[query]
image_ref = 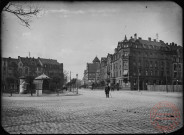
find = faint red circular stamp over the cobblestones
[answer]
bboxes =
[150,101,181,133]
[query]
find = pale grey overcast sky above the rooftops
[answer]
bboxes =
[1,2,182,79]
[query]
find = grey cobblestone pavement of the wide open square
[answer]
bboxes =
[1,89,183,134]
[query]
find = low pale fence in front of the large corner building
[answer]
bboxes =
[147,85,183,92]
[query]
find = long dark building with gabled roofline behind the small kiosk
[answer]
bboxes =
[2,56,64,92]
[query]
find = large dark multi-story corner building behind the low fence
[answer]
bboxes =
[112,34,183,90]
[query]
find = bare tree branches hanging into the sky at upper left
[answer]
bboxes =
[2,2,40,28]
